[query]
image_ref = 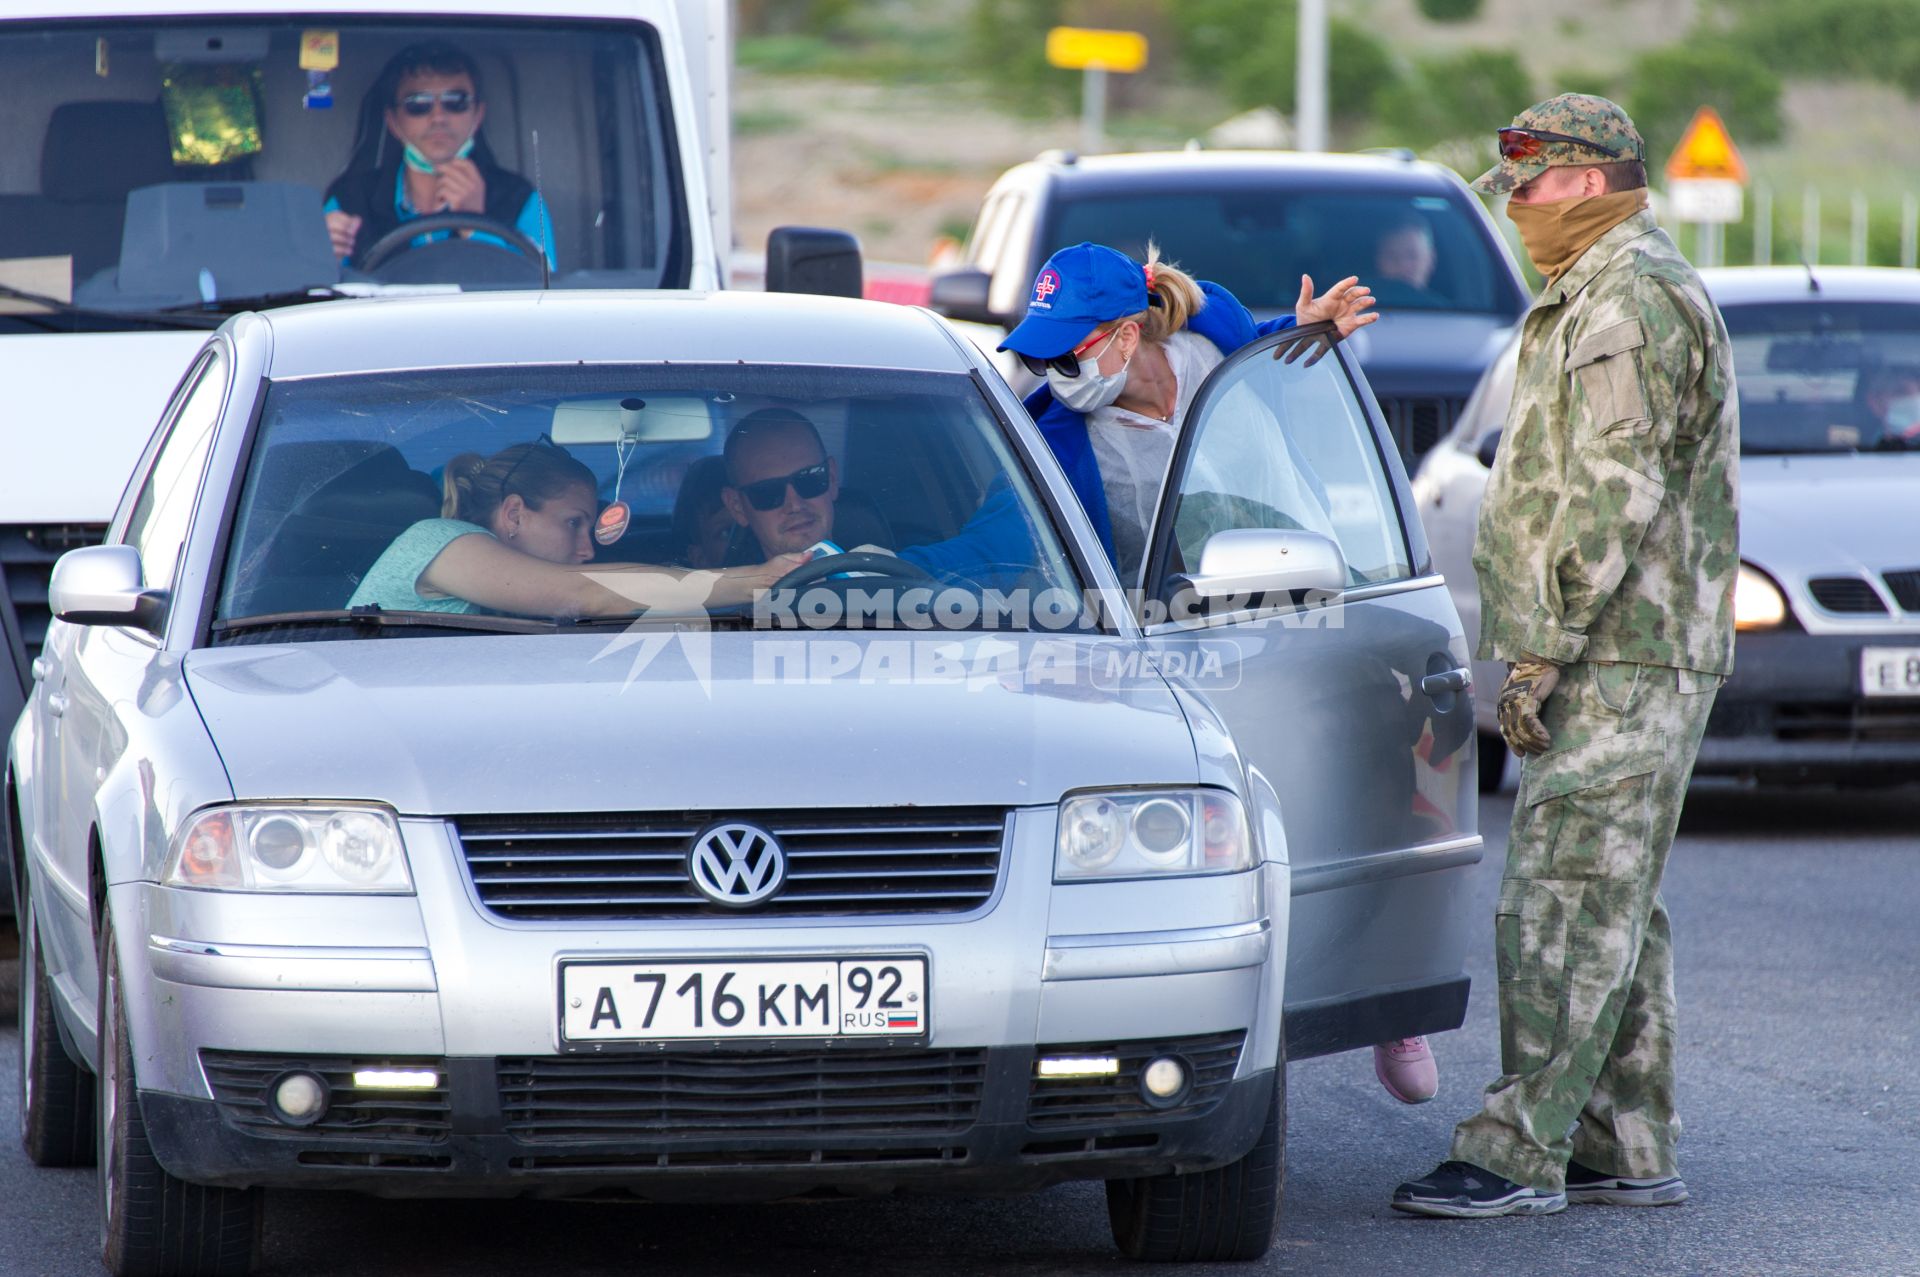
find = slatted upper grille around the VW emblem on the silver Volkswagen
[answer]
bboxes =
[455,808,1006,922]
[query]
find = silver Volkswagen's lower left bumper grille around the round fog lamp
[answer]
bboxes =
[200,1050,451,1143]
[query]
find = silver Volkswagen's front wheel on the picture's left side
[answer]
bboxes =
[94,910,261,1277]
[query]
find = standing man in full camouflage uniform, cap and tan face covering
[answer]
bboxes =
[1392,94,1740,1217]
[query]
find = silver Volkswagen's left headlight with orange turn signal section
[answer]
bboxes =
[161,805,413,895]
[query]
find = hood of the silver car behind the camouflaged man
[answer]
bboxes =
[1740,453,1920,578]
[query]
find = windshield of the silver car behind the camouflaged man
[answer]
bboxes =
[1722,301,1920,453]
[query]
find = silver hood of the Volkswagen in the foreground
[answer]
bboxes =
[186,632,1198,816]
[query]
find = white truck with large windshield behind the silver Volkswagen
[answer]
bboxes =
[0,0,860,926]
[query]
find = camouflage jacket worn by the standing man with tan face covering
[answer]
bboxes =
[1473,209,1740,674]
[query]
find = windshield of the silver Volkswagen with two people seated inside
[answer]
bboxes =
[215,365,1081,639]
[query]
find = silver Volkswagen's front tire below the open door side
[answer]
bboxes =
[1106,1048,1286,1264]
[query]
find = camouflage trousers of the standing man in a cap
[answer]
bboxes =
[1450,663,1724,1191]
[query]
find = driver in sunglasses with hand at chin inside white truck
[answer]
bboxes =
[326,44,555,267]
